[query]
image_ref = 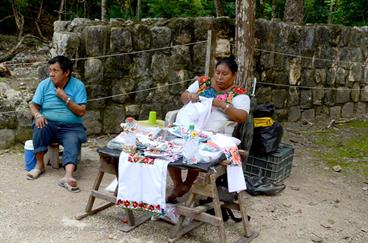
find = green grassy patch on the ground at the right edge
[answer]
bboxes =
[311,121,368,178]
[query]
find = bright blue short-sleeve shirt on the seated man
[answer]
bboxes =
[32,77,87,124]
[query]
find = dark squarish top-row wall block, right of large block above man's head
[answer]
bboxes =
[110,27,133,53]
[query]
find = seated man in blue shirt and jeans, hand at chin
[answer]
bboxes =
[27,56,87,192]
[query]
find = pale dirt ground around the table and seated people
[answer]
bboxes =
[0,123,368,243]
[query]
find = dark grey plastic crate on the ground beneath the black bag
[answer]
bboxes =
[244,144,294,182]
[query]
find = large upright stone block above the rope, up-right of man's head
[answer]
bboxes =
[83,25,109,57]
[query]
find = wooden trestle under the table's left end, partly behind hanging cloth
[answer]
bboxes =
[75,149,151,232]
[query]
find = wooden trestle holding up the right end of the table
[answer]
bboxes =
[169,165,258,243]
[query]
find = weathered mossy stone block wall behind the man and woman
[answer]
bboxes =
[0,17,368,148]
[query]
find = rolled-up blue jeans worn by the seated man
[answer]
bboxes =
[32,120,87,167]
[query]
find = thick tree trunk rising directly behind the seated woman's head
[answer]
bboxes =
[235,0,256,88]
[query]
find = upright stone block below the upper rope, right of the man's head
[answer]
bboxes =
[84,58,104,84]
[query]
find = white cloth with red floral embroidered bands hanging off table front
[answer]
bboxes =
[116,152,169,215]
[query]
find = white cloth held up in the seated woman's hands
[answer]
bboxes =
[175,96,213,130]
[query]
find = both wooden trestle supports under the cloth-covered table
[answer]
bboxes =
[75,147,258,242]
